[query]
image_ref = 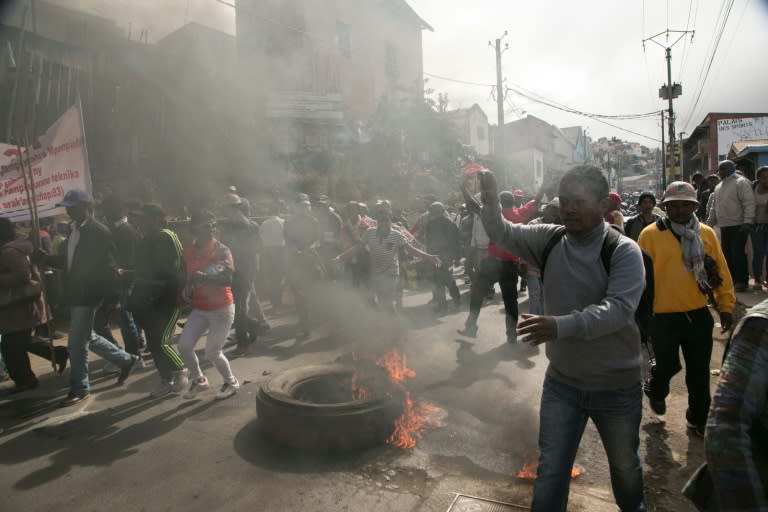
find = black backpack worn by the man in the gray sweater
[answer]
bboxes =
[541,226,654,343]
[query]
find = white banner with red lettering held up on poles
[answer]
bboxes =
[0,105,91,222]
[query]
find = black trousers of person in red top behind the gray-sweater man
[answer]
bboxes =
[466,258,518,336]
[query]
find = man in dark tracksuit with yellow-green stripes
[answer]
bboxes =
[126,204,188,398]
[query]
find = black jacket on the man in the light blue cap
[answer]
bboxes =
[46,218,120,306]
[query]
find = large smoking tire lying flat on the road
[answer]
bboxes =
[256,364,403,452]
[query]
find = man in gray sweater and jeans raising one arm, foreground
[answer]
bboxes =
[465,166,646,512]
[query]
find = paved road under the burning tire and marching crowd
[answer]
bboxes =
[0,282,760,512]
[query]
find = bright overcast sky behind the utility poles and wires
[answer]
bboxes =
[409,0,768,145]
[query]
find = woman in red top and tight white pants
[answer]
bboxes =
[179,212,240,400]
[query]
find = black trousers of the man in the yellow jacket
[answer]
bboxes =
[648,308,714,425]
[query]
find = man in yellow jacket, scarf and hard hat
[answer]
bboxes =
[637,181,736,436]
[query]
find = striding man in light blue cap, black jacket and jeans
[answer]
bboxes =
[35,189,139,407]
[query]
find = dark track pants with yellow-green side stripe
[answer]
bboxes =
[134,307,184,381]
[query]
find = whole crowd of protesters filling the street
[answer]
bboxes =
[0,161,768,511]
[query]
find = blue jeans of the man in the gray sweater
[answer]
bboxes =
[531,376,646,512]
